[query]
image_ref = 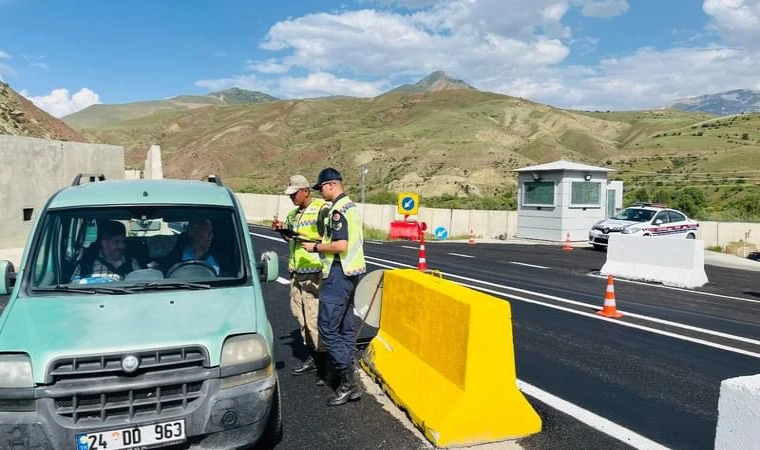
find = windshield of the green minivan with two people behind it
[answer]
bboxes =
[28,206,248,294]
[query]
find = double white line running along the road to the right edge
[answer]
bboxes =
[360,256,760,358]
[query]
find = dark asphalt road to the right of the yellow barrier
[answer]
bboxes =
[256,229,760,449]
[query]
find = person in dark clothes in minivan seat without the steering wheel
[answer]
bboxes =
[71,220,141,284]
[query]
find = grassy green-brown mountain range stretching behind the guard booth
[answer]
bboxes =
[0,72,760,220]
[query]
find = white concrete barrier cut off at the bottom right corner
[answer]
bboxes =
[715,375,760,450]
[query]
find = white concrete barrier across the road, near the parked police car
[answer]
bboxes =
[601,234,707,289]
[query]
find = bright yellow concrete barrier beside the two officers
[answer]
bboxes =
[361,270,541,447]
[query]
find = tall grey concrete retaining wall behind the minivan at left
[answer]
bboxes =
[0,135,125,248]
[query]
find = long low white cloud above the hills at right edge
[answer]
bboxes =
[483,46,760,110]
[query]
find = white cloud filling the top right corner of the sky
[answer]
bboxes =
[702,0,760,49]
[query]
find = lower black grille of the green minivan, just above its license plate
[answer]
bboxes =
[54,381,203,424]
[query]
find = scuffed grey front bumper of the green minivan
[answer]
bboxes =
[0,374,277,450]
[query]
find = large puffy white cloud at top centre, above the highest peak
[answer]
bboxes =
[252,7,569,75]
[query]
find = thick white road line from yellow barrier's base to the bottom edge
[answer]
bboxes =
[517,379,668,450]
